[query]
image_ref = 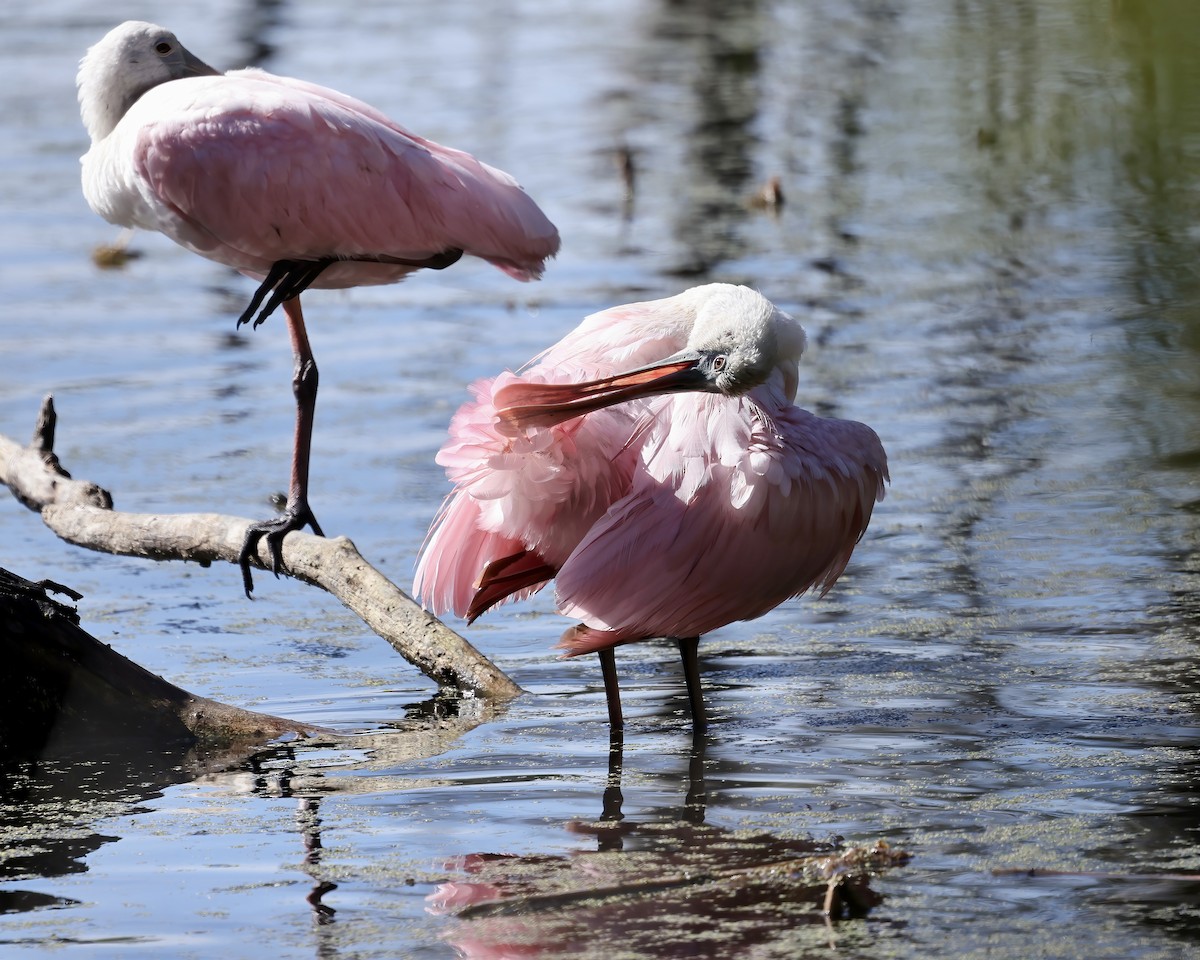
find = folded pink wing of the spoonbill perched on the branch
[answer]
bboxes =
[130,70,558,286]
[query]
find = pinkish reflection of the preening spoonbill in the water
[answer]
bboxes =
[427,731,908,959]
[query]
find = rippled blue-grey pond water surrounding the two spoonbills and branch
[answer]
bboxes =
[0,0,1200,959]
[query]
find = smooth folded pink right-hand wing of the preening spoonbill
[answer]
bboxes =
[556,396,888,655]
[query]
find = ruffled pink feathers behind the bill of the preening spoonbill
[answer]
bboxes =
[413,296,689,616]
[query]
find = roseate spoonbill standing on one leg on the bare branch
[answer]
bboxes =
[77,20,558,596]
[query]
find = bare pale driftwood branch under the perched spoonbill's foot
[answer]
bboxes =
[0,397,521,698]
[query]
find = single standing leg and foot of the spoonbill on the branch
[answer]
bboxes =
[238,296,324,596]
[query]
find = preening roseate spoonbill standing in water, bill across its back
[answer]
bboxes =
[414,283,889,730]
